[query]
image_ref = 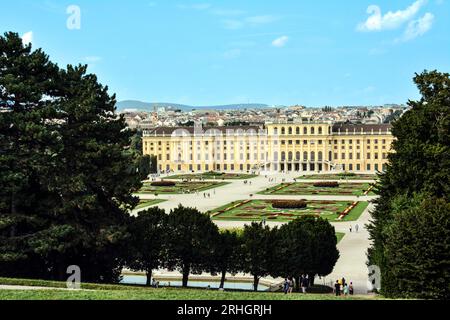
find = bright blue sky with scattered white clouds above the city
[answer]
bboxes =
[0,0,450,106]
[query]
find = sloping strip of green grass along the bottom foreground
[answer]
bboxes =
[0,278,380,300]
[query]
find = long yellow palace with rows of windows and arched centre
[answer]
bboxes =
[143,122,394,173]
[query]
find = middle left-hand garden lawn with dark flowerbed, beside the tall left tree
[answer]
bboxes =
[138,181,228,194]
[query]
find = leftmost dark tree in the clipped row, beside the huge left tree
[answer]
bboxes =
[127,207,167,286]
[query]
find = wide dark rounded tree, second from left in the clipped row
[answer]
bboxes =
[166,205,219,287]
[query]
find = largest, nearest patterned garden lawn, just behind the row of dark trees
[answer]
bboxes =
[208,200,369,222]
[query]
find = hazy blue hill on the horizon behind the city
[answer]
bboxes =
[116,100,269,111]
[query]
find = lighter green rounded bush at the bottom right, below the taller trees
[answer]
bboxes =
[384,196,450,300]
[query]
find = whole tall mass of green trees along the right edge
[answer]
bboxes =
[369,71,450,299]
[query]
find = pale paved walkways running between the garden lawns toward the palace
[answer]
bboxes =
[133,174,376,294]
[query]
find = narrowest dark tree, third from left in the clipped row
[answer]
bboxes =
[211,230,241,289]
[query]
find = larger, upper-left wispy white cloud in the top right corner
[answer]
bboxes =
[357,0,427,31]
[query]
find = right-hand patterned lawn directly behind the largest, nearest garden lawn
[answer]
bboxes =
[258,182,374,196]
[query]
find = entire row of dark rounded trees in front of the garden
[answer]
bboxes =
[126,206,339,290]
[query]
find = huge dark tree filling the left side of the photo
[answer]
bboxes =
[0,33,140,282]
